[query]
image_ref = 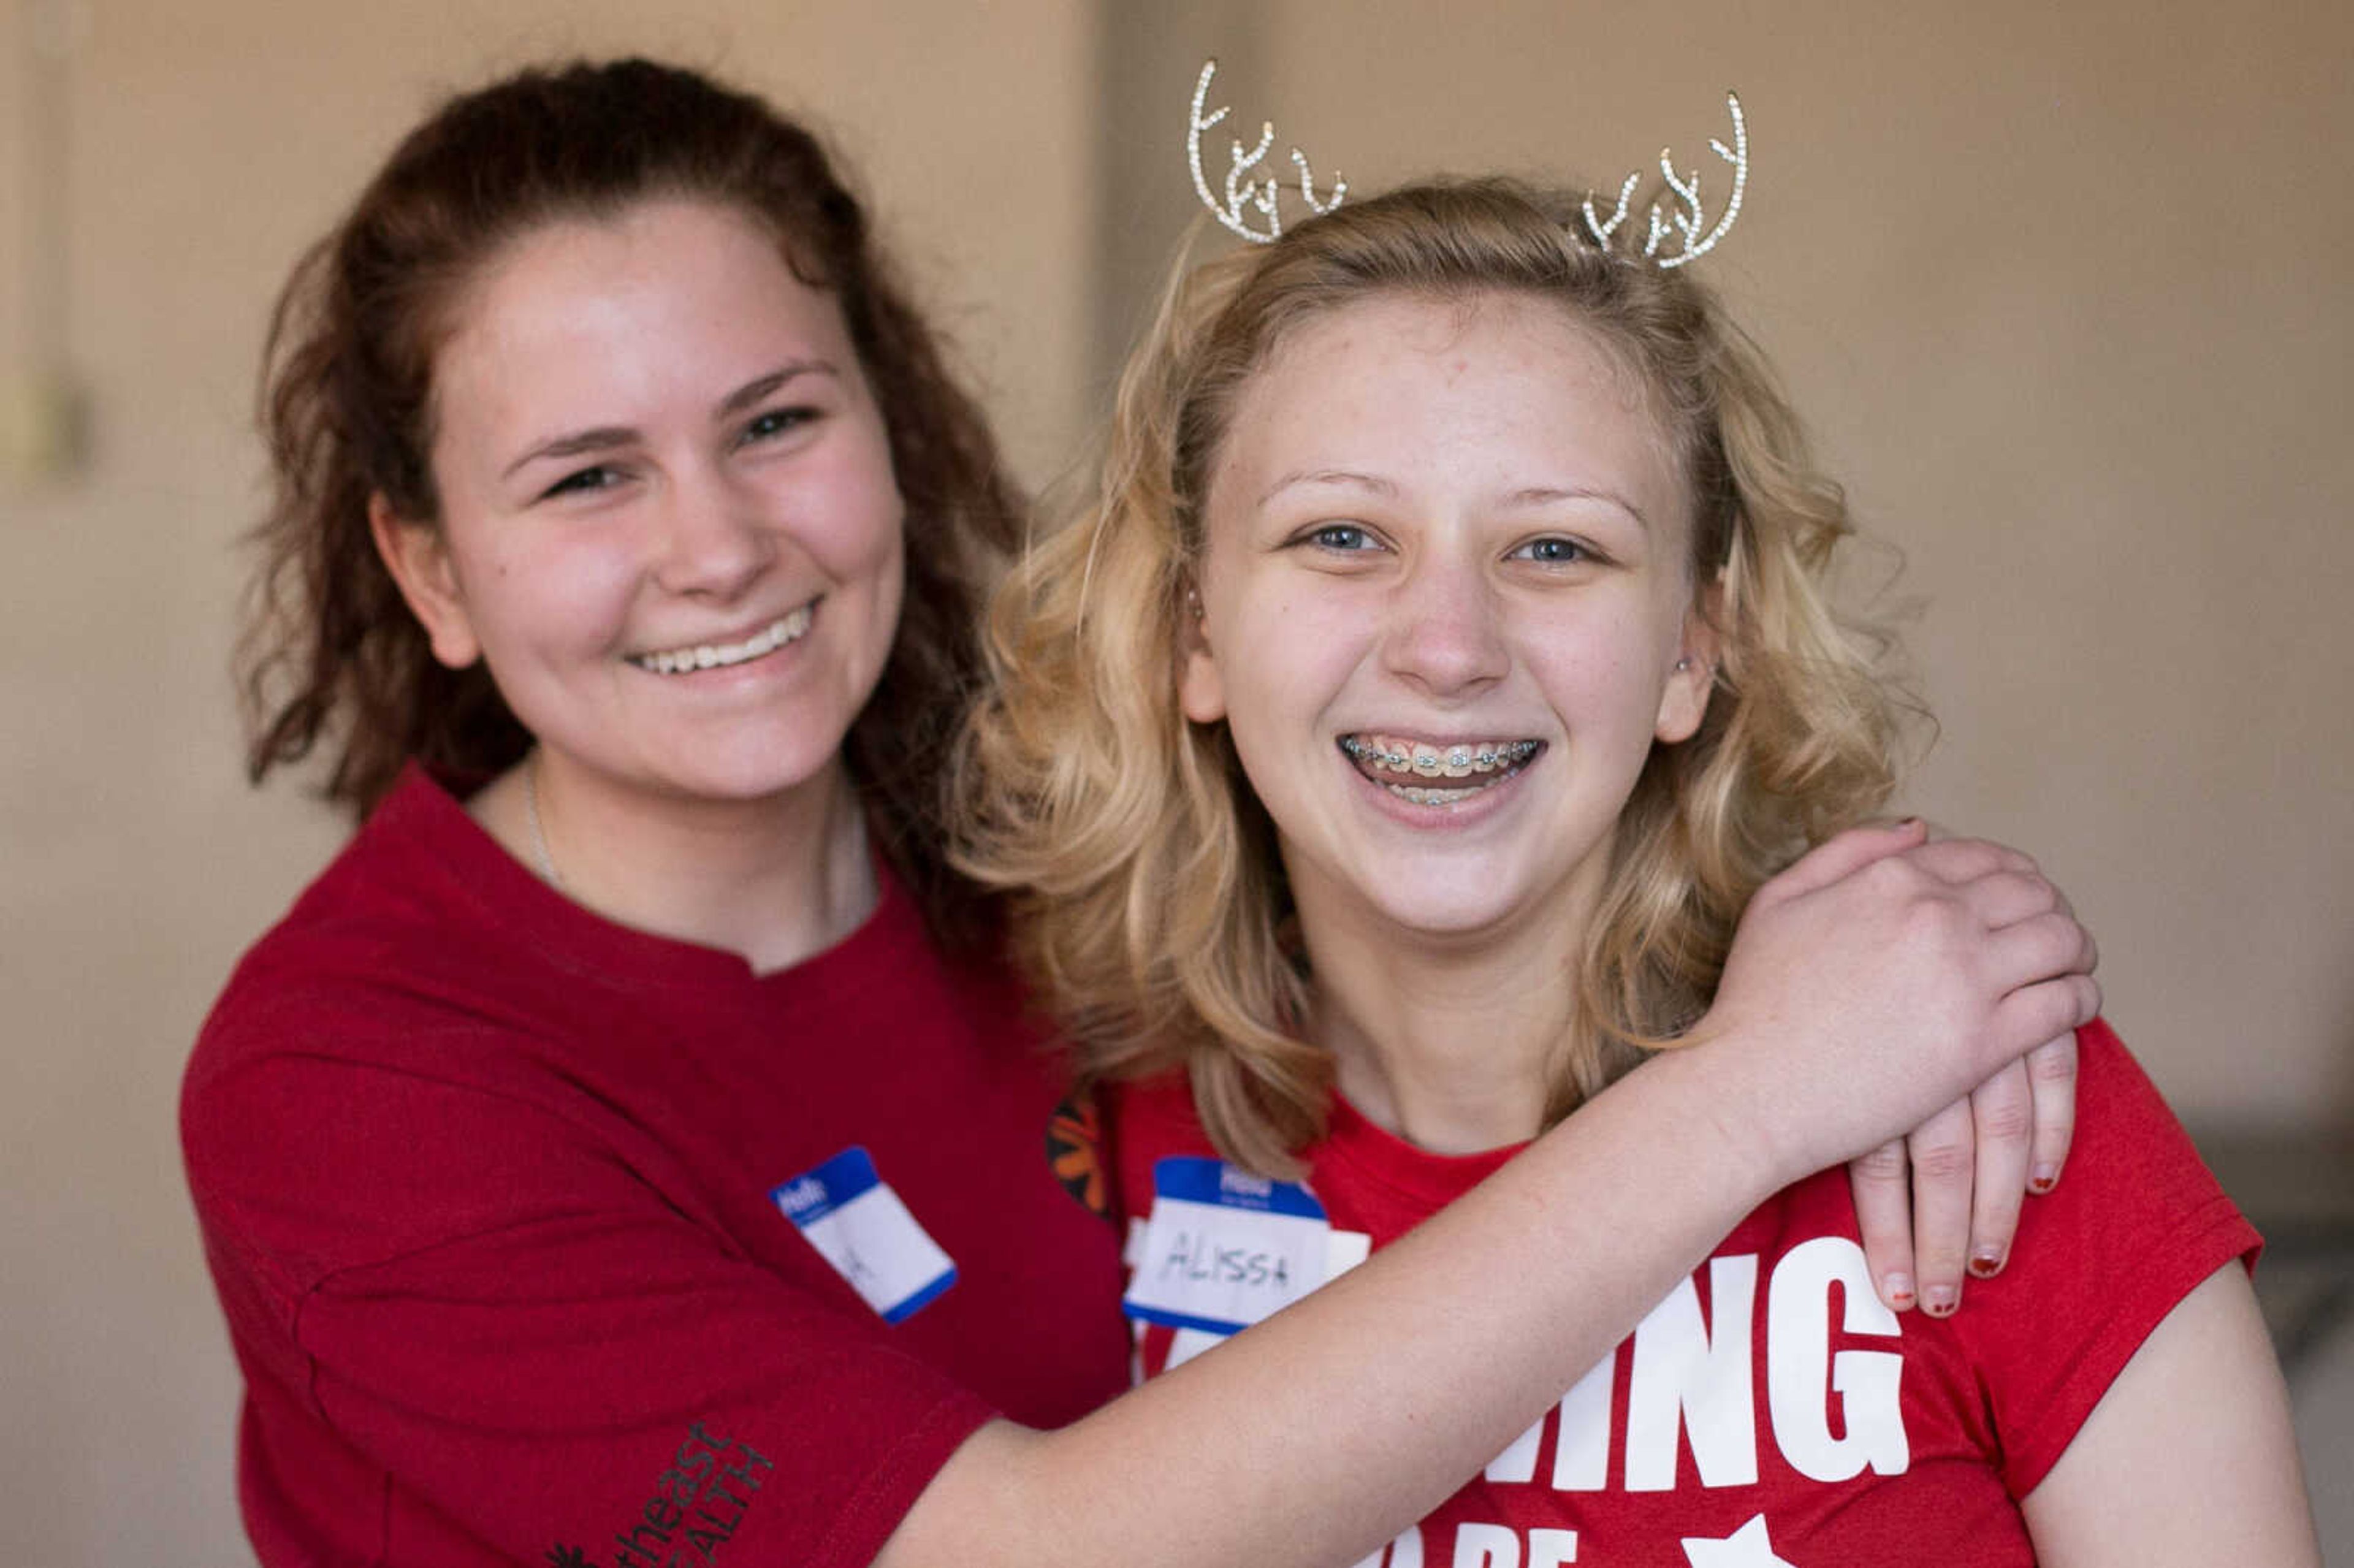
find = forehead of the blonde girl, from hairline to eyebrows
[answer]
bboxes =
[1210,289,1683,518]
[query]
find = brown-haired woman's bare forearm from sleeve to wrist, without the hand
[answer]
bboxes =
[880,1035,1787,1568]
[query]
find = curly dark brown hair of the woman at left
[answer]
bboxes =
[238,59,1022,935]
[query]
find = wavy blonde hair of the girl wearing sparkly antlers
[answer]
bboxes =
[956,179,1914,1175]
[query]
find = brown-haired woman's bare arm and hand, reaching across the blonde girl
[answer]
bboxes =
[875,829,2097,1568]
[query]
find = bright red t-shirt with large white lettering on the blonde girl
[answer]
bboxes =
[1107,1022,2258,1568]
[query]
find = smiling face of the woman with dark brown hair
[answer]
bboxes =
[375,202,904,801]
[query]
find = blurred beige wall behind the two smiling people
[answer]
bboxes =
[0,0,2354,1566]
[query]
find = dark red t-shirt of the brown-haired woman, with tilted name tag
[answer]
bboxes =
[181,772,1127,1568]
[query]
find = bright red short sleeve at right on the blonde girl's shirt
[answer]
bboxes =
[1954,1019,2262,1498]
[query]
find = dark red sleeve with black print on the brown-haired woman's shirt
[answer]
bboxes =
[184,1026,989,1568]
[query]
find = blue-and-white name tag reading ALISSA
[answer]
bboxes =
[1121,1156,1332,1335]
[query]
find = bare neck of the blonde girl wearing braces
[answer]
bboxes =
[1295,857,1594,1154]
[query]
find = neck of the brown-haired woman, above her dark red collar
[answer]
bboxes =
[468,751,878,972]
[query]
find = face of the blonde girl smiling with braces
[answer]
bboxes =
[1179,294,1714,951]
